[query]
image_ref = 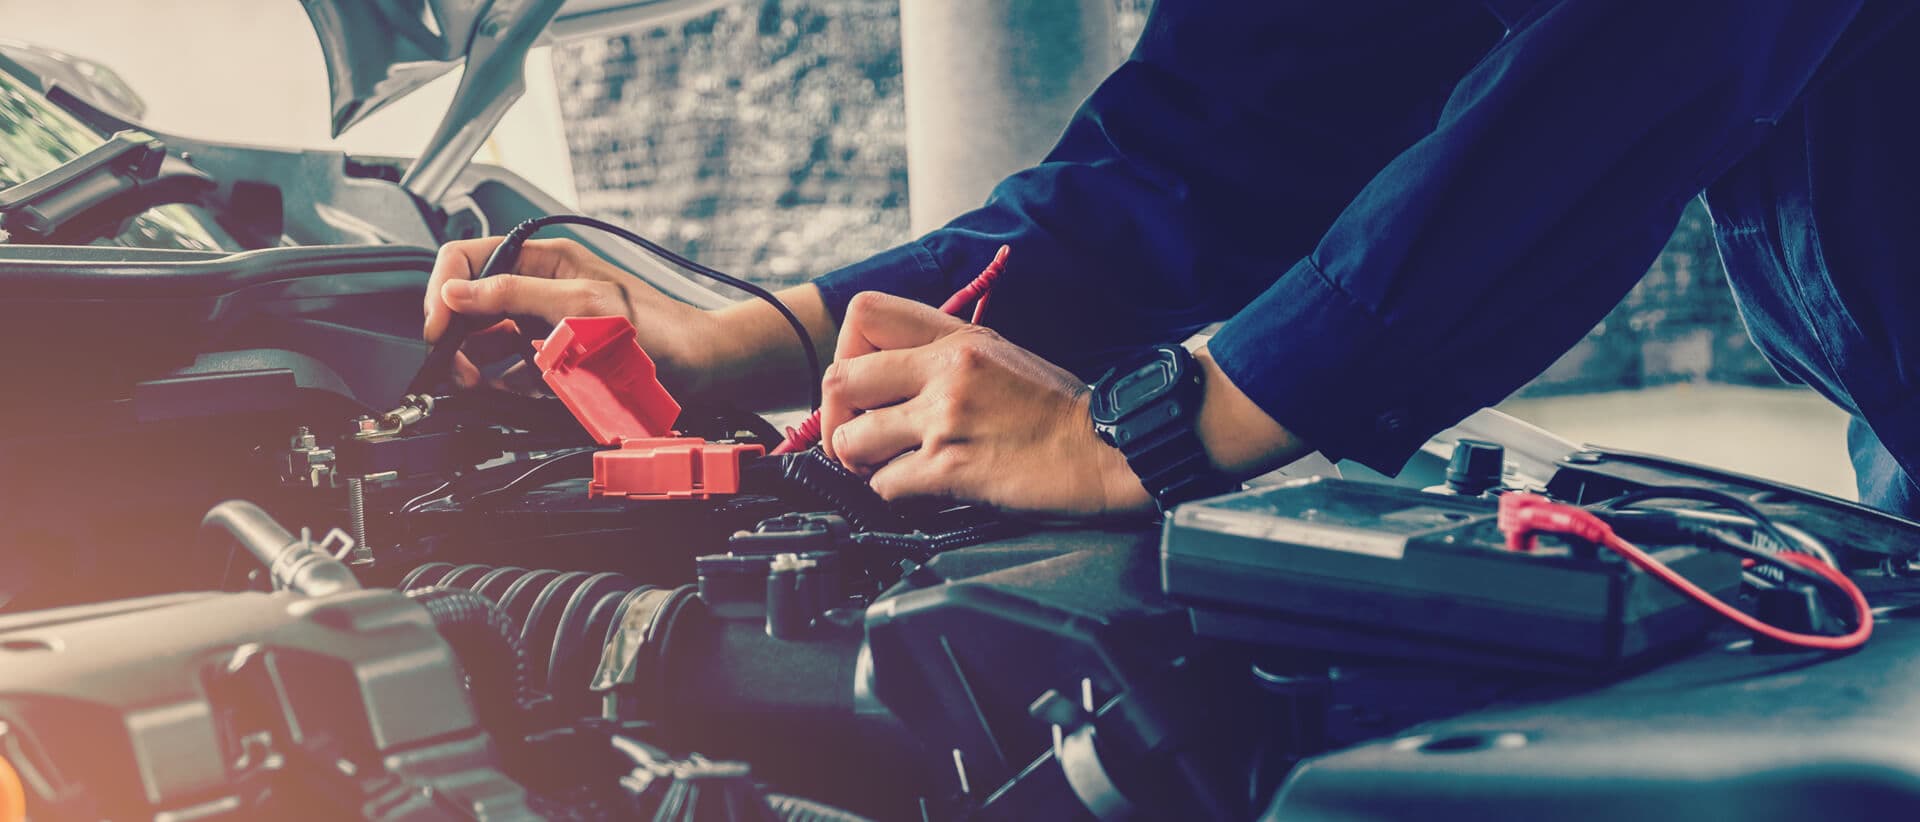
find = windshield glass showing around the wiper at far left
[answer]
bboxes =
[0,71,221,252]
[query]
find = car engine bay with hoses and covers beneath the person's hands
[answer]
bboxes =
[11,239,1920,820]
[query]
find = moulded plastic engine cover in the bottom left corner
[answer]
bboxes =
[0,592,534,820]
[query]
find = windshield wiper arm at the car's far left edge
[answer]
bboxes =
[0,131,215,242]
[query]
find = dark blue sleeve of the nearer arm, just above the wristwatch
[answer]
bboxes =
[1210,0,1857,472]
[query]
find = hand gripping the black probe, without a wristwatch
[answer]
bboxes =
[424,236,714,392]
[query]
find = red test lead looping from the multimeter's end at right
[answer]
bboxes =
[1500,494,1874,651]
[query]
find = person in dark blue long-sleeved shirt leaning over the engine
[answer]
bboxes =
[426,0,1920,517]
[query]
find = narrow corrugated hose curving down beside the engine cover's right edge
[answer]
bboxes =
[407,588,532,732]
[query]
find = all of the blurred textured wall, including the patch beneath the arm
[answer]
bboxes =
[553,0,1778,396]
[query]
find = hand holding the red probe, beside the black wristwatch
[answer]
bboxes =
[820,292,1152,517]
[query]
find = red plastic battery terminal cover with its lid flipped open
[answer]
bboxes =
[534,317,766,499]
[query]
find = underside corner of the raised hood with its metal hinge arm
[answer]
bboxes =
[301,0,728,200]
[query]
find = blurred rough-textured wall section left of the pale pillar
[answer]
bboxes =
[553,0,906,284]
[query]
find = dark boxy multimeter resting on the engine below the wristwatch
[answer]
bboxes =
[1162,478,1741,670]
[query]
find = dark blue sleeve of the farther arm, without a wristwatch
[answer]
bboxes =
[816,0,1503,375]
